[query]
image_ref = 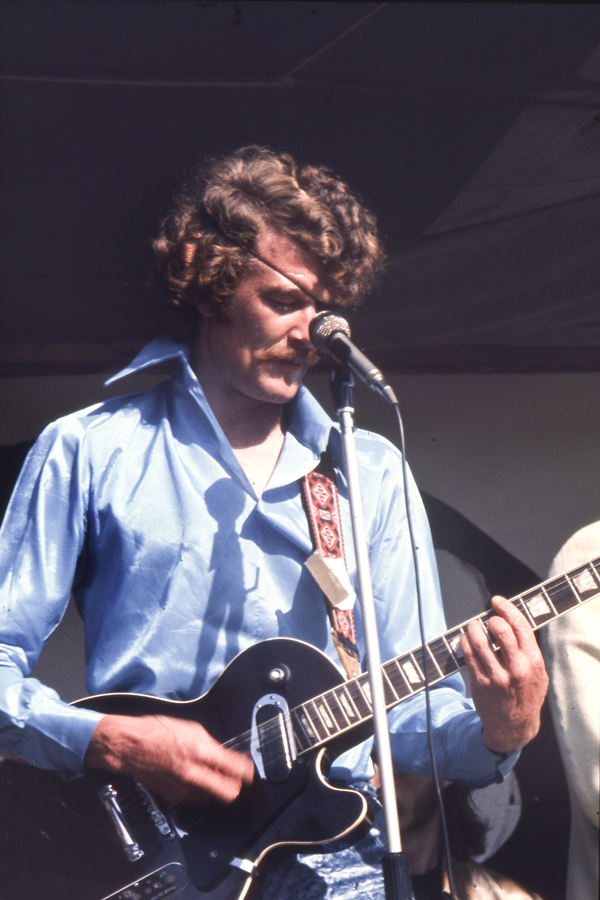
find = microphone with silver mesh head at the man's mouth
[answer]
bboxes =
[308,310,398,406]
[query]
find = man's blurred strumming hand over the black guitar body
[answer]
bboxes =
[84,715,254,806]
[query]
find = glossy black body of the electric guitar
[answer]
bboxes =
[0,638,370,900]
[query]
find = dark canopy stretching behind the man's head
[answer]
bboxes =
[0,0,600,375]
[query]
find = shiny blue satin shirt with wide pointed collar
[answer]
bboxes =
[0,339,516,785]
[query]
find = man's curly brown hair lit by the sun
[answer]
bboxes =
[153,146,383,338]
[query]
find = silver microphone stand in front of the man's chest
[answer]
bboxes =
[331,366,412,900]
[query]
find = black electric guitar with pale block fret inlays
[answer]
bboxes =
[0,557,600,900]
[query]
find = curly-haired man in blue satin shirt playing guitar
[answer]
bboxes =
[0,147,546,892]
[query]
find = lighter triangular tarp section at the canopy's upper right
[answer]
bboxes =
[361,46,600,352]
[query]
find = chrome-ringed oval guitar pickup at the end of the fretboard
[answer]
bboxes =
[250,694,296,784]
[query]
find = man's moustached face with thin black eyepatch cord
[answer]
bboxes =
[194,228,329,403]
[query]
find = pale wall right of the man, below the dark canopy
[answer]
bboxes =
[304,373,600,576]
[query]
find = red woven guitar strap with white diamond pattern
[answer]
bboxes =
[301,460,360,678]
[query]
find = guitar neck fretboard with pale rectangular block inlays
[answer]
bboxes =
[291,557,600,753]
